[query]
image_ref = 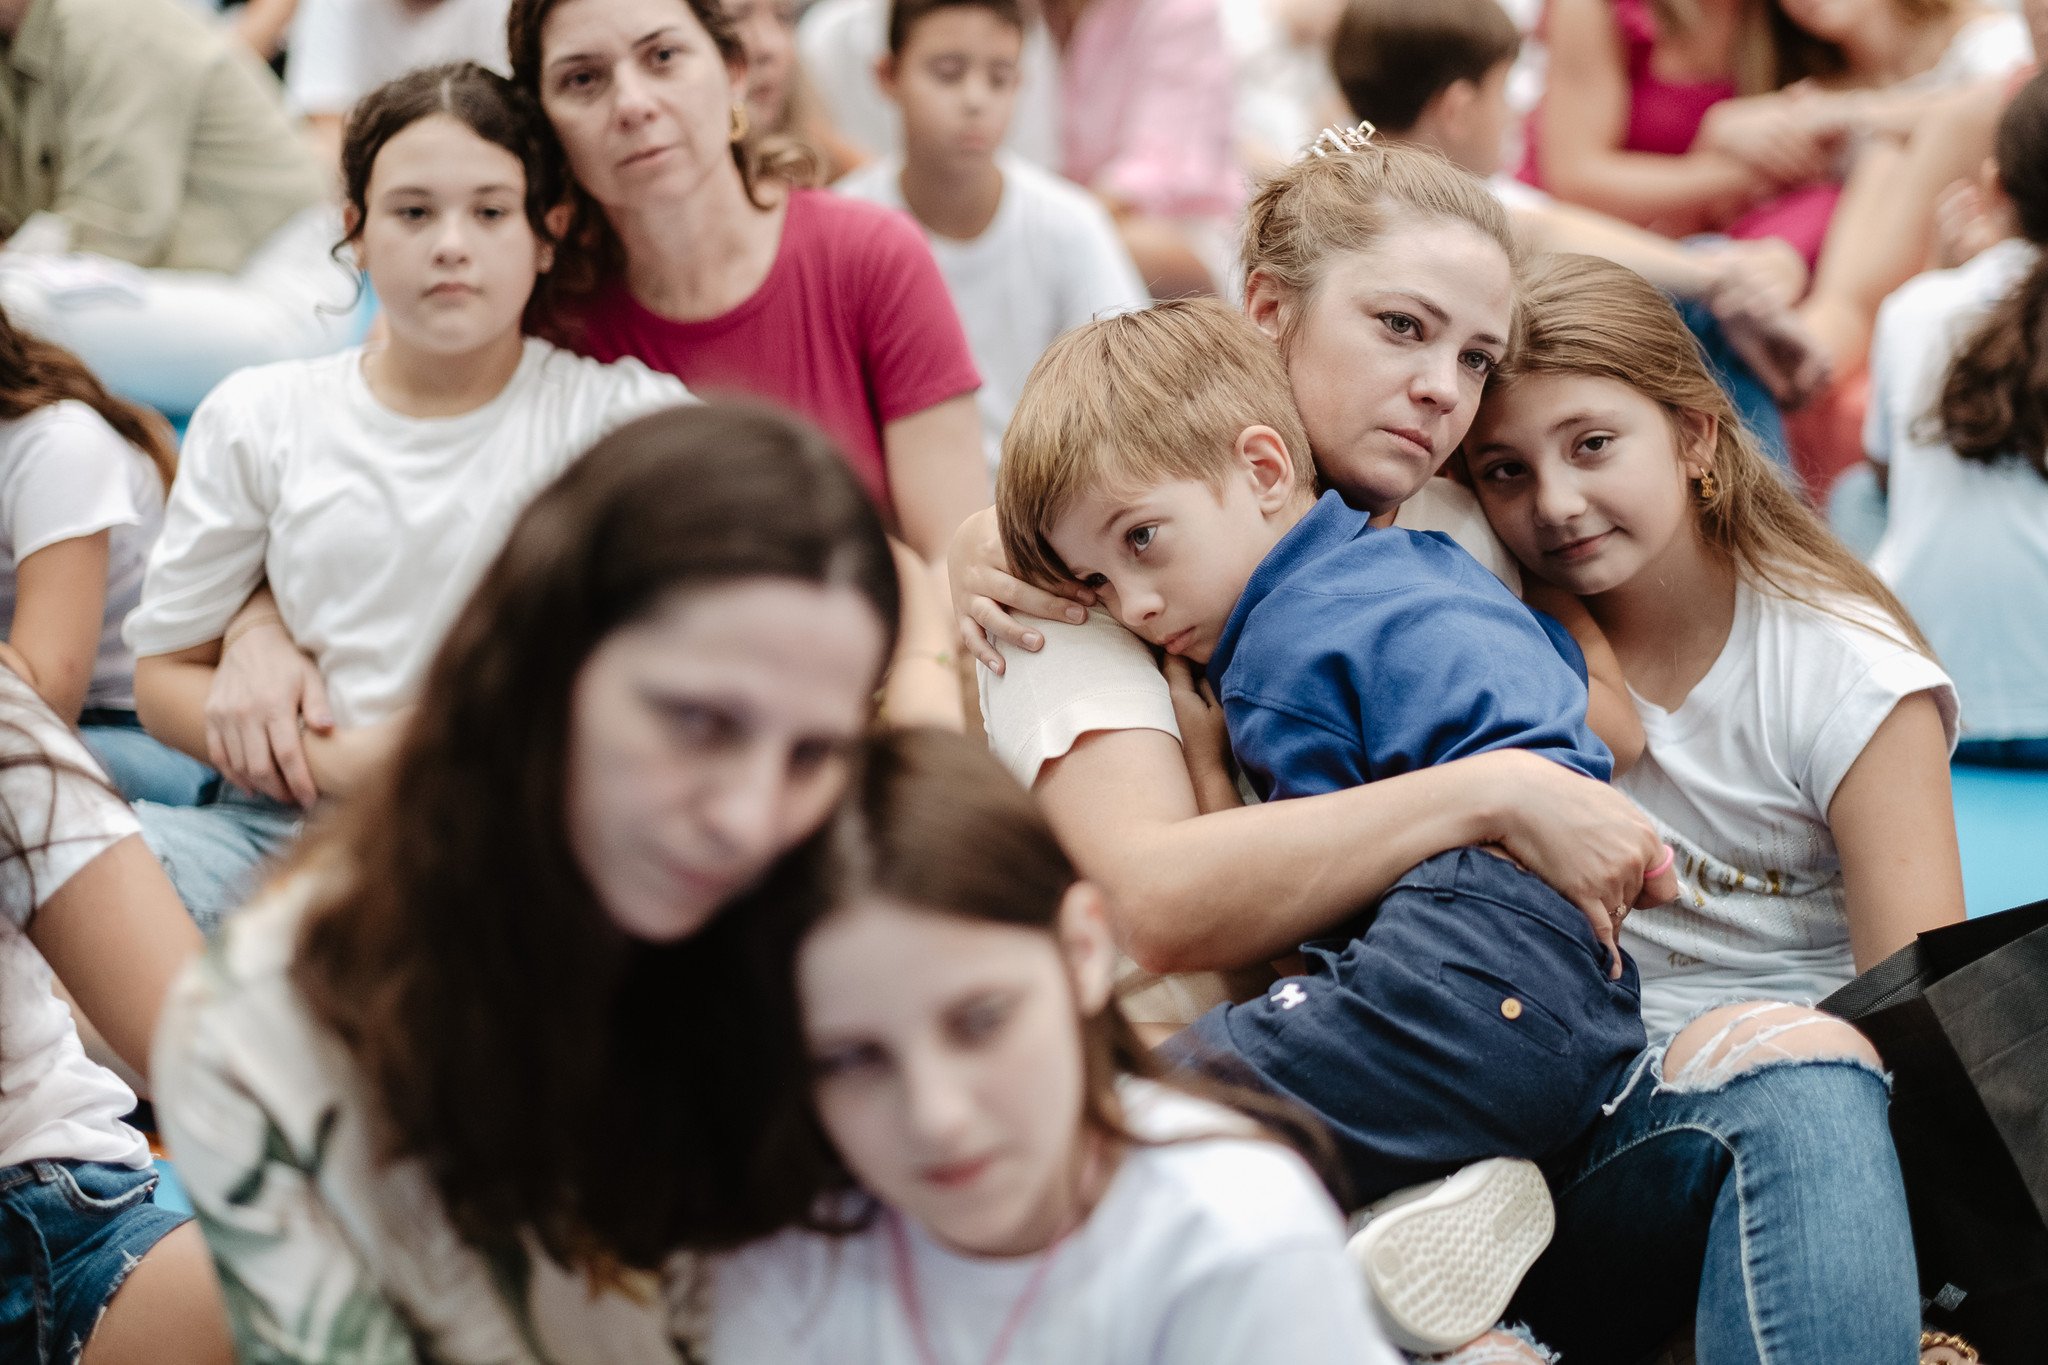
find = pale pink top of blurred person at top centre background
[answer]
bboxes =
[1059,0,1245,217]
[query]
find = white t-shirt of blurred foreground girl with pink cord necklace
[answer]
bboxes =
[709,1083,1401,1365]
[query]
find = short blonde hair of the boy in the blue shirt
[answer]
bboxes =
[995,299,1315,583]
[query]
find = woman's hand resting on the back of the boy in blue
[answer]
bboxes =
[1466,749,1677,978]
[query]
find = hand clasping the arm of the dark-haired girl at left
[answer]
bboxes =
[205,618,334,808]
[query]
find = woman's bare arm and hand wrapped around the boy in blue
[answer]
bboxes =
[1036,731,1677,972]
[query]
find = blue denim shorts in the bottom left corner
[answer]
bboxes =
[0,1160,184,1365]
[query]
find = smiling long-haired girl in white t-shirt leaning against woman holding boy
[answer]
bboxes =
[1464,256,1962,1038]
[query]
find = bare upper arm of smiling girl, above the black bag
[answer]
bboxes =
[1827,692,1964,972]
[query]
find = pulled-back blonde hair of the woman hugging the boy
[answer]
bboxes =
[1241,141,1522,352]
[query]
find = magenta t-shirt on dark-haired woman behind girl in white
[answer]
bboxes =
[565,190,981,512]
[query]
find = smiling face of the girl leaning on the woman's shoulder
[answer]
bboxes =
[1464,375,1714,598]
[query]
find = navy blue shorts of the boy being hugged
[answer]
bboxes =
[1167,847,1645,1205]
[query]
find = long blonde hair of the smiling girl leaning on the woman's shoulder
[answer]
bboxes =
[1487,256,1933,659]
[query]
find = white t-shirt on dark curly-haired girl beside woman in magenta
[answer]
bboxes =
[127,338,690,726]
